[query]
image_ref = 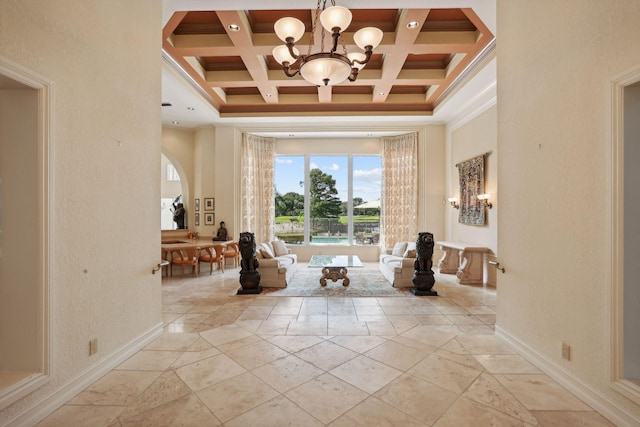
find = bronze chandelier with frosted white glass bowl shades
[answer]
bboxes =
[273,0,383,86]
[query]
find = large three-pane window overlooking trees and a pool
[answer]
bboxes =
[275,155,382,245]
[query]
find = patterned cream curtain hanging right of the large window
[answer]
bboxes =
[380,132,418,249]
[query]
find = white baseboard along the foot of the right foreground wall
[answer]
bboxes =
[495,326,640,426]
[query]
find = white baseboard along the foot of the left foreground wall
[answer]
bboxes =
[6,323,162,427]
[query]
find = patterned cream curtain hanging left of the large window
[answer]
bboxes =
[240,134,275,244]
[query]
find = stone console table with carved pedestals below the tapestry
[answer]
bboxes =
[436,242,489,285]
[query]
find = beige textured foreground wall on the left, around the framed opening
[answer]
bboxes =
[0,0,162,421]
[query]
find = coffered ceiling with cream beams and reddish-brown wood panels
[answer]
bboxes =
[162,1,495,118]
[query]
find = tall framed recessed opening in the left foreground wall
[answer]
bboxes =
[0,57,51,409]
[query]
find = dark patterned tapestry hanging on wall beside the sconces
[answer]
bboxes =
[456,153,489,225]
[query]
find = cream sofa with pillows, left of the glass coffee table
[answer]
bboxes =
[256,240,298,288]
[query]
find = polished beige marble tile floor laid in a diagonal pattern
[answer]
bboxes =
[38,264,613,427]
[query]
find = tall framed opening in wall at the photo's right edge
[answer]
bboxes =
[612,66,640,403]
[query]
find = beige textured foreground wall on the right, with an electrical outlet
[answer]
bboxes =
[496,0,640,419]
